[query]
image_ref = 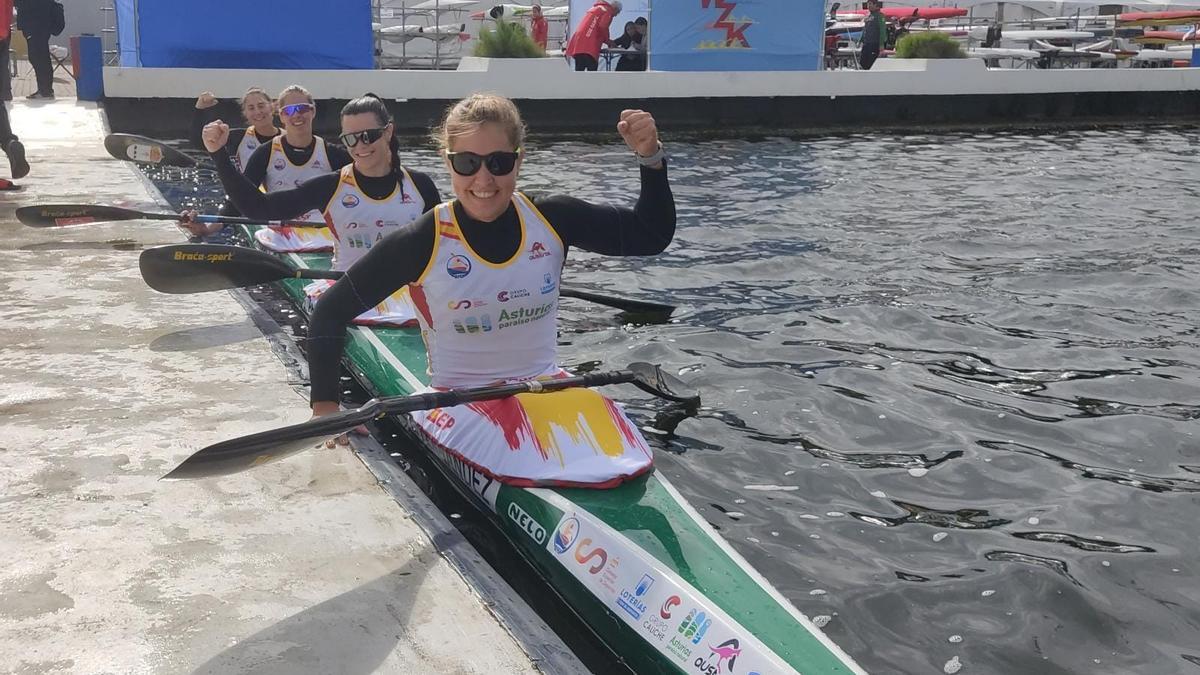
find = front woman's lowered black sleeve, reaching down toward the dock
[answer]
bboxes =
[308,218,437,402]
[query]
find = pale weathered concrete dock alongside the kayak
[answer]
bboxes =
[0,98,566,675]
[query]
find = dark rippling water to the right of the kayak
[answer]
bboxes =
[147,127,1200,674]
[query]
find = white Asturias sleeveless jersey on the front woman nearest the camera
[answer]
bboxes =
[410,193,565,387]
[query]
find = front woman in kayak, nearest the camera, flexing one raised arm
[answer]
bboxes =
[308,95,676,486]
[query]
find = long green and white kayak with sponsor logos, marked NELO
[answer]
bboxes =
[238,227,864,675]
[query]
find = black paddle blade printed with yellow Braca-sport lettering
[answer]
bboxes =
[138,244,296,293]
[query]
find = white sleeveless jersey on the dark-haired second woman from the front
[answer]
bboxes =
[322,165,425,269]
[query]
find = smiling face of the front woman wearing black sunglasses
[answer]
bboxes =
[446,123,521,222]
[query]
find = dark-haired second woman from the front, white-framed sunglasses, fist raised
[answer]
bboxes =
[194,95,440,270]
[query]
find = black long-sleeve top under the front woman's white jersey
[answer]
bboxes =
[308,166,676,402]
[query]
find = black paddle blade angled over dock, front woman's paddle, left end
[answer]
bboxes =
[162,404,378,480]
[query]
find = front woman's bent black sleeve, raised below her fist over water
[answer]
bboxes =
[534,163,676,256]
